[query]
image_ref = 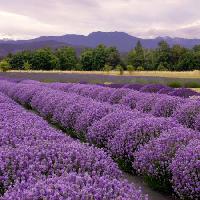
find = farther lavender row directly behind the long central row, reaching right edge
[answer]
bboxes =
[44,83,200,131]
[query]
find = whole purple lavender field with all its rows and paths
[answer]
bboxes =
[0,76,200,200]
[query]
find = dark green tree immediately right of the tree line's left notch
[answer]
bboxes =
[80,49,93,71]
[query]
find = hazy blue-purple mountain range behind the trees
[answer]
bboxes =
[0,31,200,57]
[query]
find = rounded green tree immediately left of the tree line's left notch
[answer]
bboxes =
[55,47,77,70]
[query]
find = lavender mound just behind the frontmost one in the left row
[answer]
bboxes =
[0,140,121,193]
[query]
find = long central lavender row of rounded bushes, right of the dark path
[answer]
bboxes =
[0,79,199,199]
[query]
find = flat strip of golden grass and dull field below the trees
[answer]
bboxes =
[0,71,200,88]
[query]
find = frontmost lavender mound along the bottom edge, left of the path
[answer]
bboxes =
[2,173,148,200]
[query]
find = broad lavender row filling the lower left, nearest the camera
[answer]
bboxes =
[0,93,147,200]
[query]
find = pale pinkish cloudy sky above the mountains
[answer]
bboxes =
[0,0,200,39]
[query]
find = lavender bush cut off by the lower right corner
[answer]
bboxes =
[171,139,200,199]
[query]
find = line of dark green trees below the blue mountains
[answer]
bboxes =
[0,41,200,71]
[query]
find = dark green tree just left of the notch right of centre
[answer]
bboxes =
[106,47,120,67]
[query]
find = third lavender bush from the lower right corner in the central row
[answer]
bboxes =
[108,117,177,161]
